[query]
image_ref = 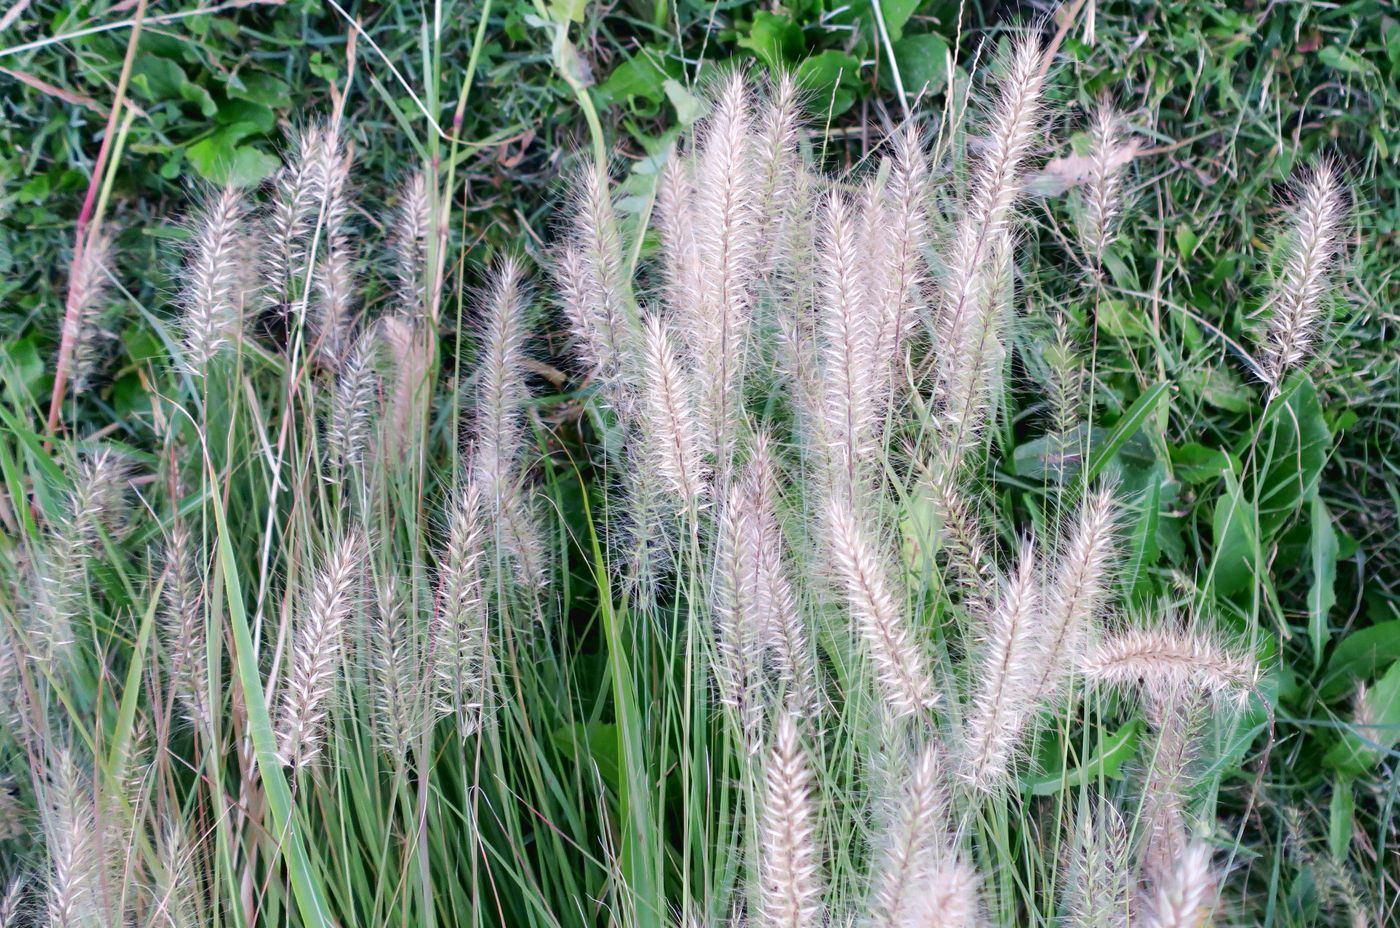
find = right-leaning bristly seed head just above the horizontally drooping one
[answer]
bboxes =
[1035,487,1119,700]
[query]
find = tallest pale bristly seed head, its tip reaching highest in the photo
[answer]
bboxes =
[935,38,1044,456]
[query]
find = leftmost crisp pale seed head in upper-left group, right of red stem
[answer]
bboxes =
[179,188,249,375]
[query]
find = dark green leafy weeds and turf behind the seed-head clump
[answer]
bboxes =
[0,0,1400,924]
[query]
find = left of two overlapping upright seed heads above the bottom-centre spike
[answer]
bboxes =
[711,481,764,753]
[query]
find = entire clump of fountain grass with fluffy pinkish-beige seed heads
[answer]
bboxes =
[0,7,1390,928]
